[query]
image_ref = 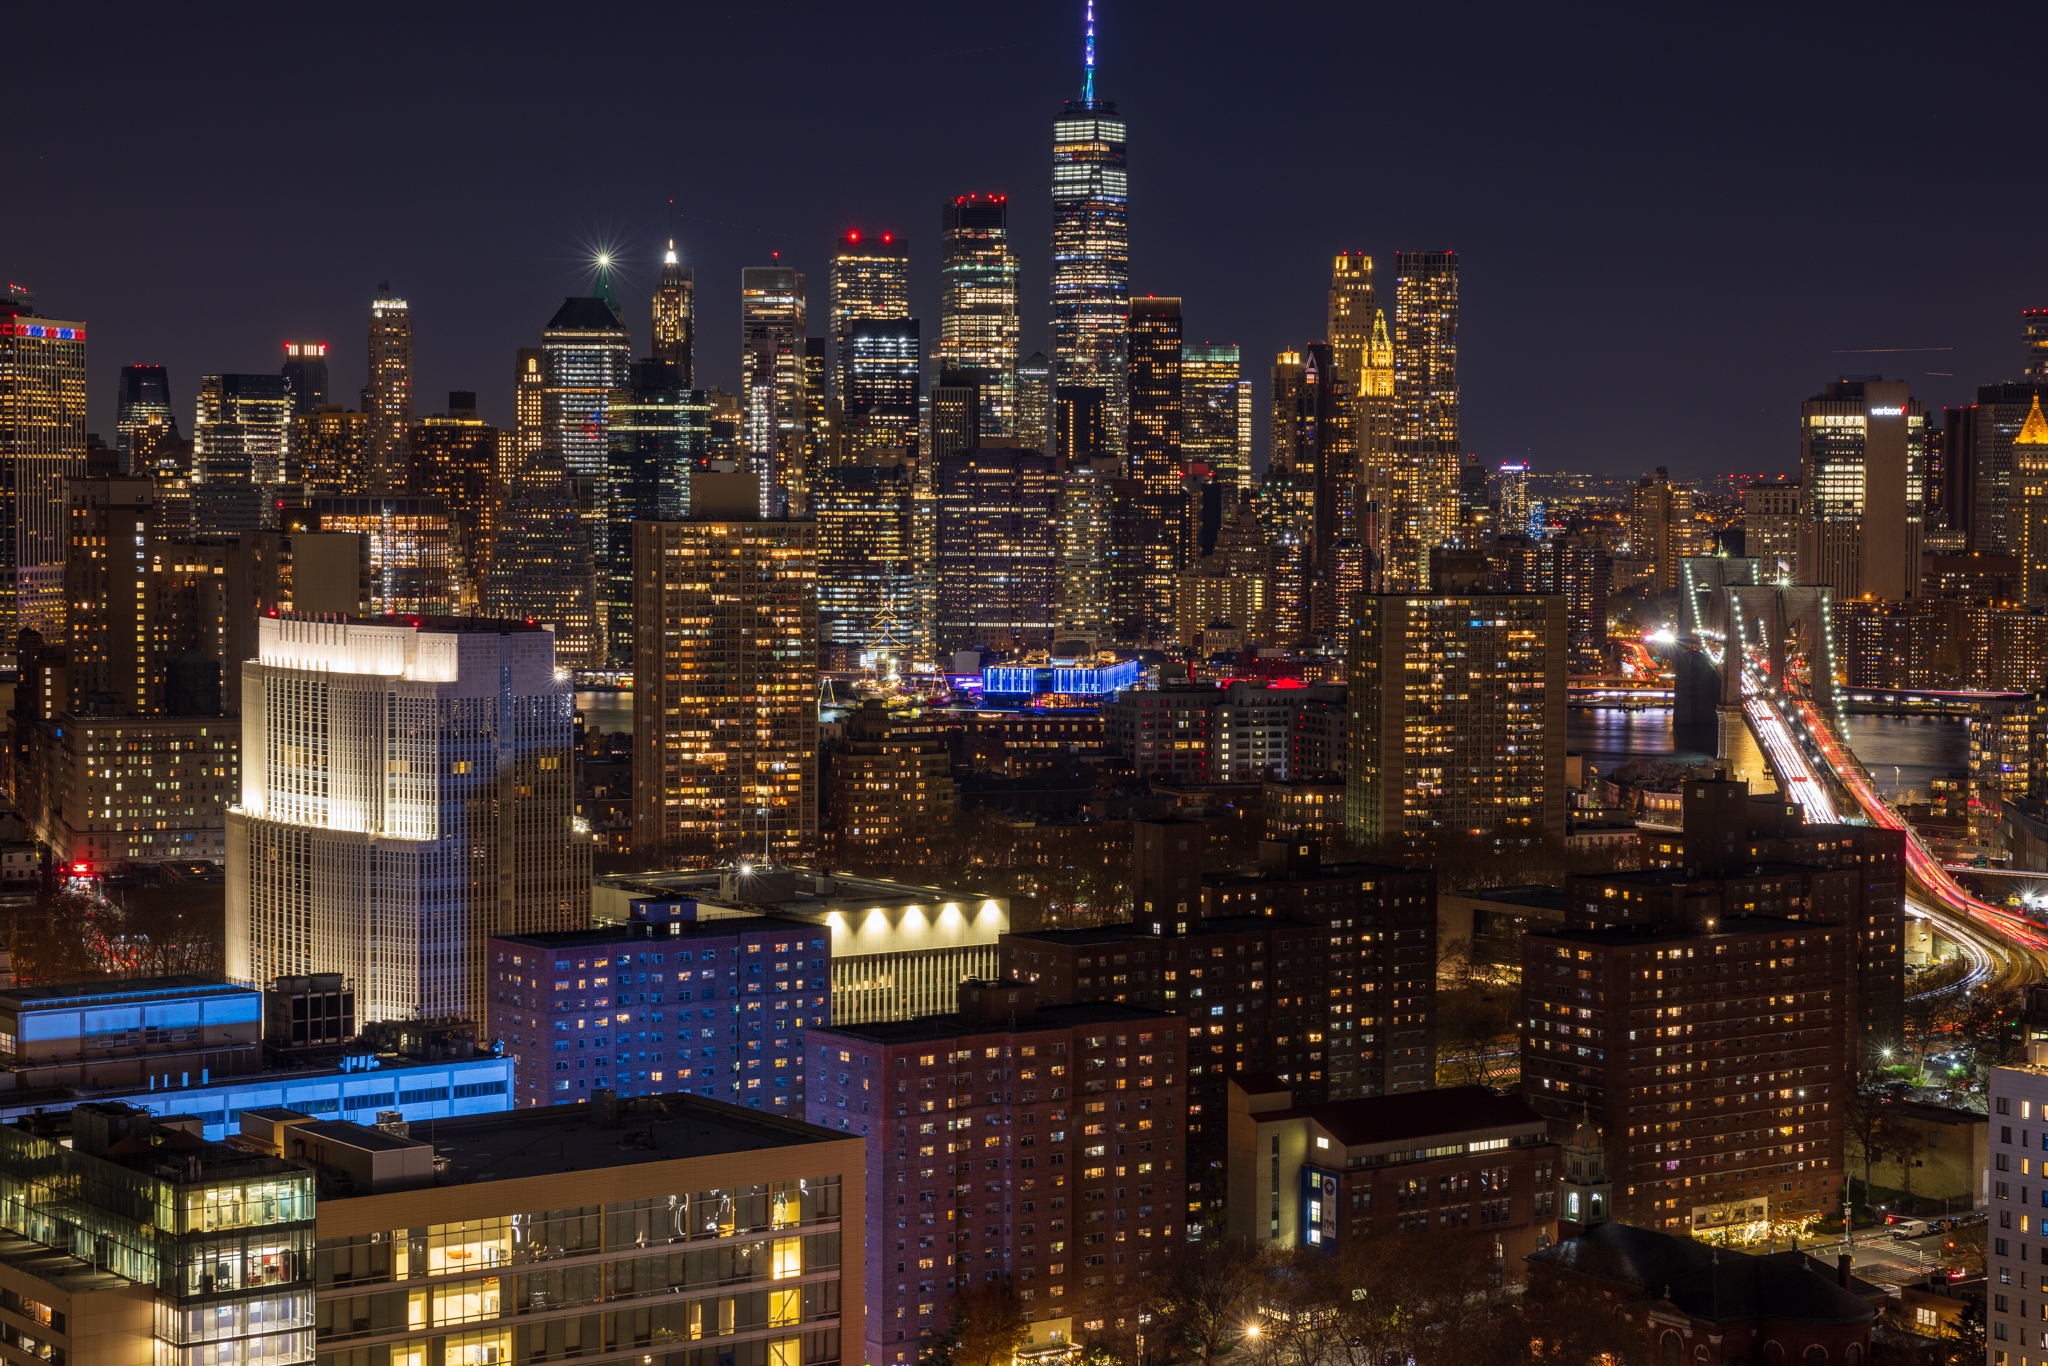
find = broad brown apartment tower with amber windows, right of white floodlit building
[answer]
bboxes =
[633,473,817,866]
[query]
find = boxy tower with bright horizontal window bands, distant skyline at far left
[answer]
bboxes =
[193,375,290,537]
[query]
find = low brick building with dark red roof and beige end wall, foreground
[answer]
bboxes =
[1225,1073,1561,1280]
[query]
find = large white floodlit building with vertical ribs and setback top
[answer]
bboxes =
[227,616,590,1020]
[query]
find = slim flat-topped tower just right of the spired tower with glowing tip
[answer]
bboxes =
[739,266,809,516]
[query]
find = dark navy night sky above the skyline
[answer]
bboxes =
[16,0,2048,477]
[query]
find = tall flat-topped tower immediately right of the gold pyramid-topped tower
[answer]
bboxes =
[1393,252,1460,561]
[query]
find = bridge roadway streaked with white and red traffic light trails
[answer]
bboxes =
[1743,680,2048,989]
